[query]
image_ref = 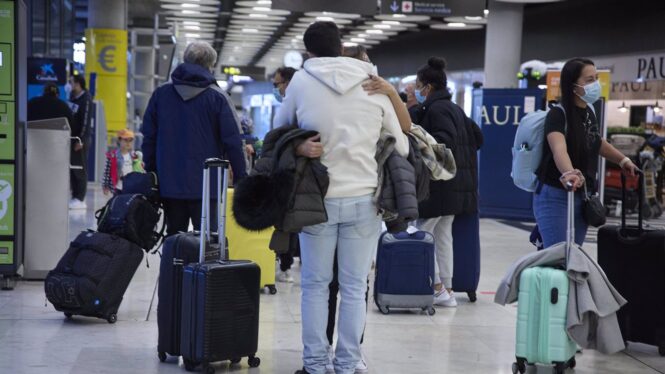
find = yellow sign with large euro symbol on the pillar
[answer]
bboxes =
[85,29,127,138]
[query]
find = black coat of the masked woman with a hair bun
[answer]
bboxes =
[411,90,483,218]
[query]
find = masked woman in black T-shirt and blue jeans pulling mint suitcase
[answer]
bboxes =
[533,58,638,248]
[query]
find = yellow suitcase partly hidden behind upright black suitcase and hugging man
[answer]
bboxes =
[226,188,277,295]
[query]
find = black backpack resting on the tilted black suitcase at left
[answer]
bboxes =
[95,194,164,251]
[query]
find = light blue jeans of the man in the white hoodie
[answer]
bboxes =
[300,195,381,374]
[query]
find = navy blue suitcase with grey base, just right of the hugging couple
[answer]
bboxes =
[374,231,436,315]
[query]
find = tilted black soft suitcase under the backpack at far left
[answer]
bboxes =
[44,231,143,323]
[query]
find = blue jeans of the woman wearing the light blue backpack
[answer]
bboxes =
[533,184,588,249]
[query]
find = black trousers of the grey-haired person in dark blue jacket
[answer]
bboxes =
[162,199,217,236]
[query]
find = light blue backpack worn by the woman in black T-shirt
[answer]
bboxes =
[510,104,596,192]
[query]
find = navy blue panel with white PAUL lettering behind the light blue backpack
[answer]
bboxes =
[473,89,544,221]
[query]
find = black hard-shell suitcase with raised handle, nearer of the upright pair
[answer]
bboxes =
[180,159,261,374]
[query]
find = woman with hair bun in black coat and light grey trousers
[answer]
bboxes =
[411,57,483,307]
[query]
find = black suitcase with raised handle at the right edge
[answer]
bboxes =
[598,175,665,356]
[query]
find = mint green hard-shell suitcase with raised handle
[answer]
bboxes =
[512,187,577,374]
